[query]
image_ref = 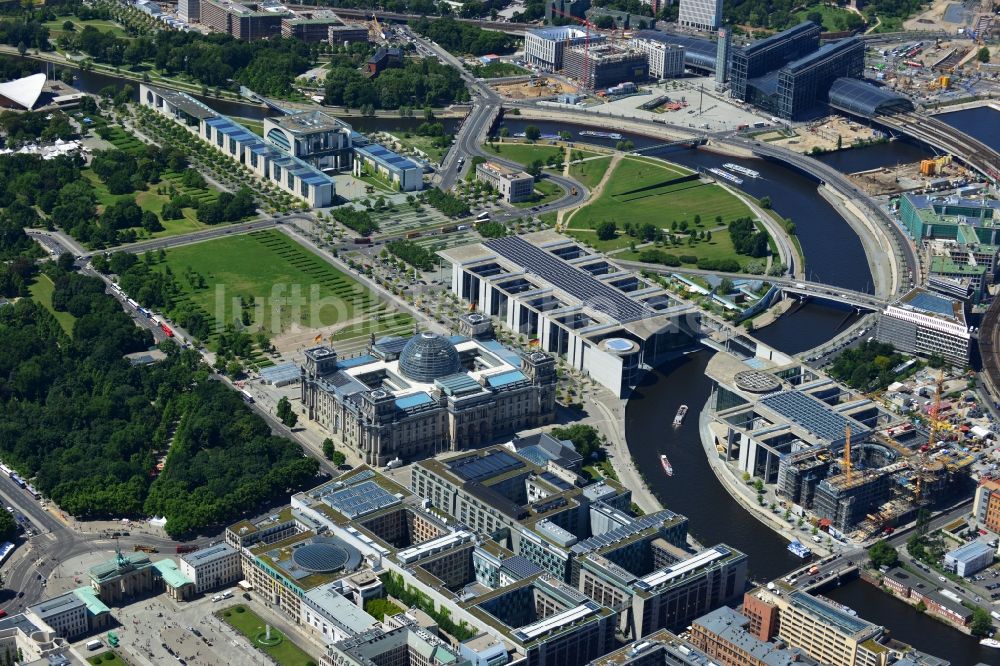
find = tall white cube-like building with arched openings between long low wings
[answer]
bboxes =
[264,111,354,171]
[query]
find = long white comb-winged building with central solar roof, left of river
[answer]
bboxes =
[438,231,698,397]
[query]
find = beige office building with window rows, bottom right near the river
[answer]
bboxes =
[743,588,888,666]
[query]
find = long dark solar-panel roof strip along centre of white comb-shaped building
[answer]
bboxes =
[484,236,656,323]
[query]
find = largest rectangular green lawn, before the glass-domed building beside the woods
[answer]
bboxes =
[156,230,396,335]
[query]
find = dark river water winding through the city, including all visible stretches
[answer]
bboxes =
[58,63,1000,666]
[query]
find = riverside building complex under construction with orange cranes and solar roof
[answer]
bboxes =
[706,352,995,543]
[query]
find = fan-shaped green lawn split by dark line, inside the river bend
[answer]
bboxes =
[567,157,752,254]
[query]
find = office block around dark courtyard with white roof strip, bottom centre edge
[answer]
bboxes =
[467,574,615,666]
